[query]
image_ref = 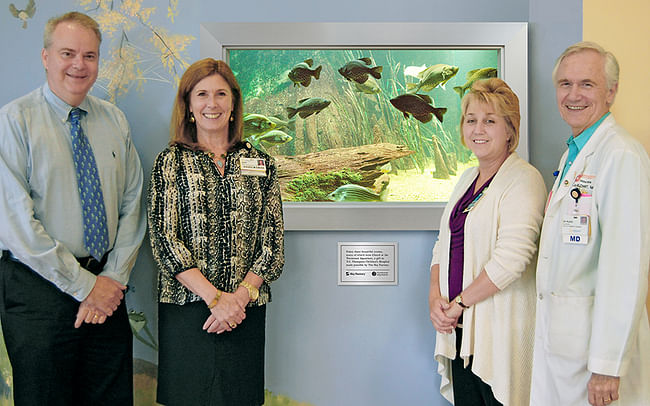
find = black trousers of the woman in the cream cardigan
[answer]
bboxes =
[451,328,503,406]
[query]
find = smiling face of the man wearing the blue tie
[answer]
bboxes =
[41,21,99,107]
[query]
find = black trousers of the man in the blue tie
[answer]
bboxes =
[0,252,133,406]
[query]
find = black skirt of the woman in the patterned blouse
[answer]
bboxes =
[157,302,266,406]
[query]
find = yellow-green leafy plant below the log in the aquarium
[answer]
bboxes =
[286,168,363,202]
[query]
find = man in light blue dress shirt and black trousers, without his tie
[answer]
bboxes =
[0,12,145,406]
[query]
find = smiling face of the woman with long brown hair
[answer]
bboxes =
[190,74,233,139]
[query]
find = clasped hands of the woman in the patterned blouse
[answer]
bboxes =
[203,288,249,334]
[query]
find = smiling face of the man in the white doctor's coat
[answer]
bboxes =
[555,50,618,137]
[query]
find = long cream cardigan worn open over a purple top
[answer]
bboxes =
[431,153,546,406]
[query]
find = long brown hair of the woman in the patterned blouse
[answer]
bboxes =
[169,58,244,146]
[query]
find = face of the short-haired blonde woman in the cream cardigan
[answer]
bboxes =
[462,101,511,166]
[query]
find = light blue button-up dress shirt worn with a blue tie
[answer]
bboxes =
[0,83,146,301]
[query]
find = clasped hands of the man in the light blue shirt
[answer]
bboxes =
[74,276,126,328]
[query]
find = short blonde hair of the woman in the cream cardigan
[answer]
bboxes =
[460,78,521,153]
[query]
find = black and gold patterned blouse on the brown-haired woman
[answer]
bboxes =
[148,143,284,305]
